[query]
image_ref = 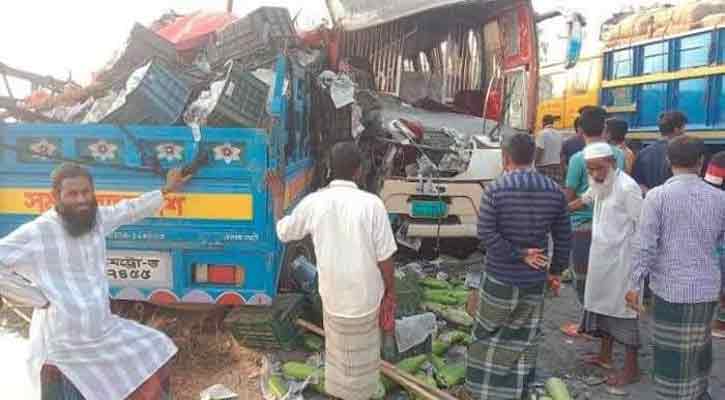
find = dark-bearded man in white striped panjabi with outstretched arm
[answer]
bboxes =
[0,163,188,400]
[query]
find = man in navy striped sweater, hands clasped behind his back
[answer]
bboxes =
[463,134,571,400]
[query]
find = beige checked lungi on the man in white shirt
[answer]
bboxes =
[324,310,381,400]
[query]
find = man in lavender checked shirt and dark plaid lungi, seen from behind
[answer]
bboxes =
[626,136,725,400]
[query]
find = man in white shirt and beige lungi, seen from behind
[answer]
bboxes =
[272,143,397,400]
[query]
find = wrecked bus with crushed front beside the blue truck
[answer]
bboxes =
[329,0,583,247]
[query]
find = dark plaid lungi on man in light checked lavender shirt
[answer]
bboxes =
[653,295,717,400]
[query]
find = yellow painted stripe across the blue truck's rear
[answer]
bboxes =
[0,188,254,221]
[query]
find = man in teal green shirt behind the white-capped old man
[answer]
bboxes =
[562,107,624,336]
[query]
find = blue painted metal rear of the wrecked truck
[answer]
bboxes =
[0,53,314,304]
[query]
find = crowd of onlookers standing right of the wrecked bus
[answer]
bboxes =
[466,107,725,400]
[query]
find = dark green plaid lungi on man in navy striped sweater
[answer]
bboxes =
[466,274,545,400]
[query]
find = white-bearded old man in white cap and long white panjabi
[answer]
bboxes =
[570,143,643,386]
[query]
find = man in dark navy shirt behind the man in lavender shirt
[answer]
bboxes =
[632,111,687,194]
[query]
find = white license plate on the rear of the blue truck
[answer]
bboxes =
[106,250,171,287]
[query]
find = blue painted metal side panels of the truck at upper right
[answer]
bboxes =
[600,28,725,145]
